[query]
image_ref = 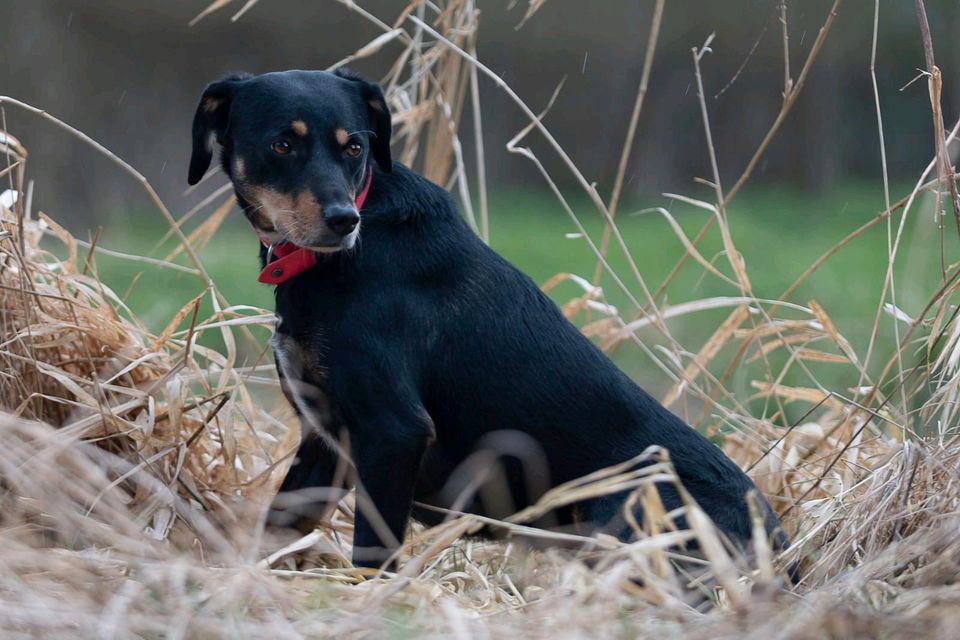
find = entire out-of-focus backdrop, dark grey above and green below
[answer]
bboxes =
[0,0,960,392]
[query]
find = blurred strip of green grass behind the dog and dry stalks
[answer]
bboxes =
[81,183,944,420]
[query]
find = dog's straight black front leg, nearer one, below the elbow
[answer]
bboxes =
[351,419,429,567]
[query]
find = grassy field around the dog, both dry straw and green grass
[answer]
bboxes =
[0,0,960,638]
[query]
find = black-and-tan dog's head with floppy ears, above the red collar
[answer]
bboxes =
[188,70,391,253]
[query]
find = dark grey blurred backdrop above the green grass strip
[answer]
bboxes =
[0,0,960,215]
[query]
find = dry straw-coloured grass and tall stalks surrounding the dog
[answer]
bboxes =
[0,0,960,638]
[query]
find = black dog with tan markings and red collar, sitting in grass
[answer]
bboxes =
[189,71,786,566]
